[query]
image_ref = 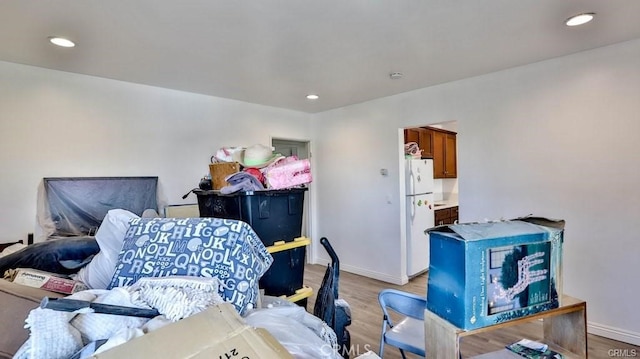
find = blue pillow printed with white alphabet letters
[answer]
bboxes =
[109,218,273,314]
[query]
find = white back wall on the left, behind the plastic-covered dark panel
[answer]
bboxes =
[0,62,311,242]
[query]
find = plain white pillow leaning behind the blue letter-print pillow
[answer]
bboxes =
[75,209,139,289]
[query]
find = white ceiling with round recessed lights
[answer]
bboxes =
[0,0,640,112]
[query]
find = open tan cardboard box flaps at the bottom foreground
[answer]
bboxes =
[91,303,293,359]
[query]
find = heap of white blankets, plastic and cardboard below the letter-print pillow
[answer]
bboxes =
[14,276,340,359]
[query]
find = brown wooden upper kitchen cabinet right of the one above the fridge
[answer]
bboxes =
[430,128,458,178]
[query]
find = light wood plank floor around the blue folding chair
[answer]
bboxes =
[304,265,640,359]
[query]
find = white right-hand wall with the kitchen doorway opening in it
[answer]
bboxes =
[313,40,640,345]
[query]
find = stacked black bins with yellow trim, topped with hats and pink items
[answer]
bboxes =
[193,144,312,307]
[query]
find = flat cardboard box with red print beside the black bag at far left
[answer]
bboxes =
[9,268,88,294]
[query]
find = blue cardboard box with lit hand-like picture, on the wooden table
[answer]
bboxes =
[427,217,564,330]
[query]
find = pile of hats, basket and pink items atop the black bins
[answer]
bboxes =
[204,144,313,194]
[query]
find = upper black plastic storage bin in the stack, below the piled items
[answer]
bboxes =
[193,188,307,246]
